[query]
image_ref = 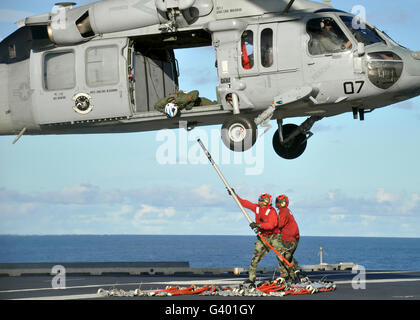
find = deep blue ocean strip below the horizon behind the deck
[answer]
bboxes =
[0,235,420,270]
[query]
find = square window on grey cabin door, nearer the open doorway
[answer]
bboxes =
[86,46,119,87]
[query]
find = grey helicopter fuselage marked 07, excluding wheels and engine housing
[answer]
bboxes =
[0,1,420,139]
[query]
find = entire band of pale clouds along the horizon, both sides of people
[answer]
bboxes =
[0,183,420,235]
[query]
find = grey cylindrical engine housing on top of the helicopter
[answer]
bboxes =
[47,0,213,45]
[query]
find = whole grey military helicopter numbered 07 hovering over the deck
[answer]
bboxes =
[0,0,420,159]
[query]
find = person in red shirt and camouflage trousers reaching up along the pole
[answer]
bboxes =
[236,193,281,285]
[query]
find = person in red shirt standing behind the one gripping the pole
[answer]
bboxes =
[276,194,300,280]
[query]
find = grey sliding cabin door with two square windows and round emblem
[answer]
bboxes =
[31,38,132,125]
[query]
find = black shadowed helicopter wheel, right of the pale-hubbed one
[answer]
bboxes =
[273,124,307,160]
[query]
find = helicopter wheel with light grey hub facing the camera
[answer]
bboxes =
[222,115,257,152]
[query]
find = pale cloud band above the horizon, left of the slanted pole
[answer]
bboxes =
[0,183,243,234]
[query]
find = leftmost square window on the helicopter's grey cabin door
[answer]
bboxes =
[44,51,76,90]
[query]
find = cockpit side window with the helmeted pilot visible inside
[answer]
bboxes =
[306,18,352,55]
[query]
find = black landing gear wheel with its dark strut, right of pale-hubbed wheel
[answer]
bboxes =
[273,117,322,160]
